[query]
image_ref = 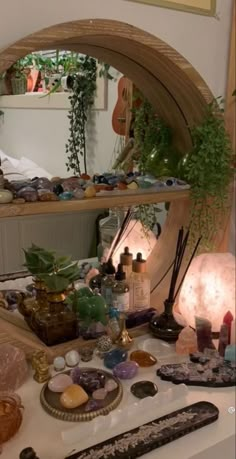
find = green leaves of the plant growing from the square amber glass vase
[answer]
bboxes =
[24,244,80,293]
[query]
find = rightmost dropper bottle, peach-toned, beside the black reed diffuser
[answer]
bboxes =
[130,252,150,311]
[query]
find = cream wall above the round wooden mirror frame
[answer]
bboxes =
[0,0,233,95]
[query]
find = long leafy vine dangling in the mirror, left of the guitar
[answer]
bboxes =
[66,56,97,175]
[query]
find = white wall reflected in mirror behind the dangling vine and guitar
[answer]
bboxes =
[0,81,117,177]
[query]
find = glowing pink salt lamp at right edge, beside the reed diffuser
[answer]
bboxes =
[178,253,235,332]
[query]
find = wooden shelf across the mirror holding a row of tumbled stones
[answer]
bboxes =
[0,188,189,218]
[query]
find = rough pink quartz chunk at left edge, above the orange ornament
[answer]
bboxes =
[0,344,28,391]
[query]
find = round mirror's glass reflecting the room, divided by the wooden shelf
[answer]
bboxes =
[0,51,189,274]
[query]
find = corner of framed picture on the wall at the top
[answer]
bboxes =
[126,0,216,16]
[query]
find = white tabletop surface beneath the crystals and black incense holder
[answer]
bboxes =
[1,335,235,459]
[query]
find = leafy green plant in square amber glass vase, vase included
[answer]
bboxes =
[25,245,80,346]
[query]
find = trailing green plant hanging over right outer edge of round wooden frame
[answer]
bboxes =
[182,99,233,250]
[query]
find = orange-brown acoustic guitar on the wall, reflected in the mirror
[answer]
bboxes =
[112,76,130,136]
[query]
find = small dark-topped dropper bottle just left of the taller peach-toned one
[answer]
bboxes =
[112,263,129,312]
